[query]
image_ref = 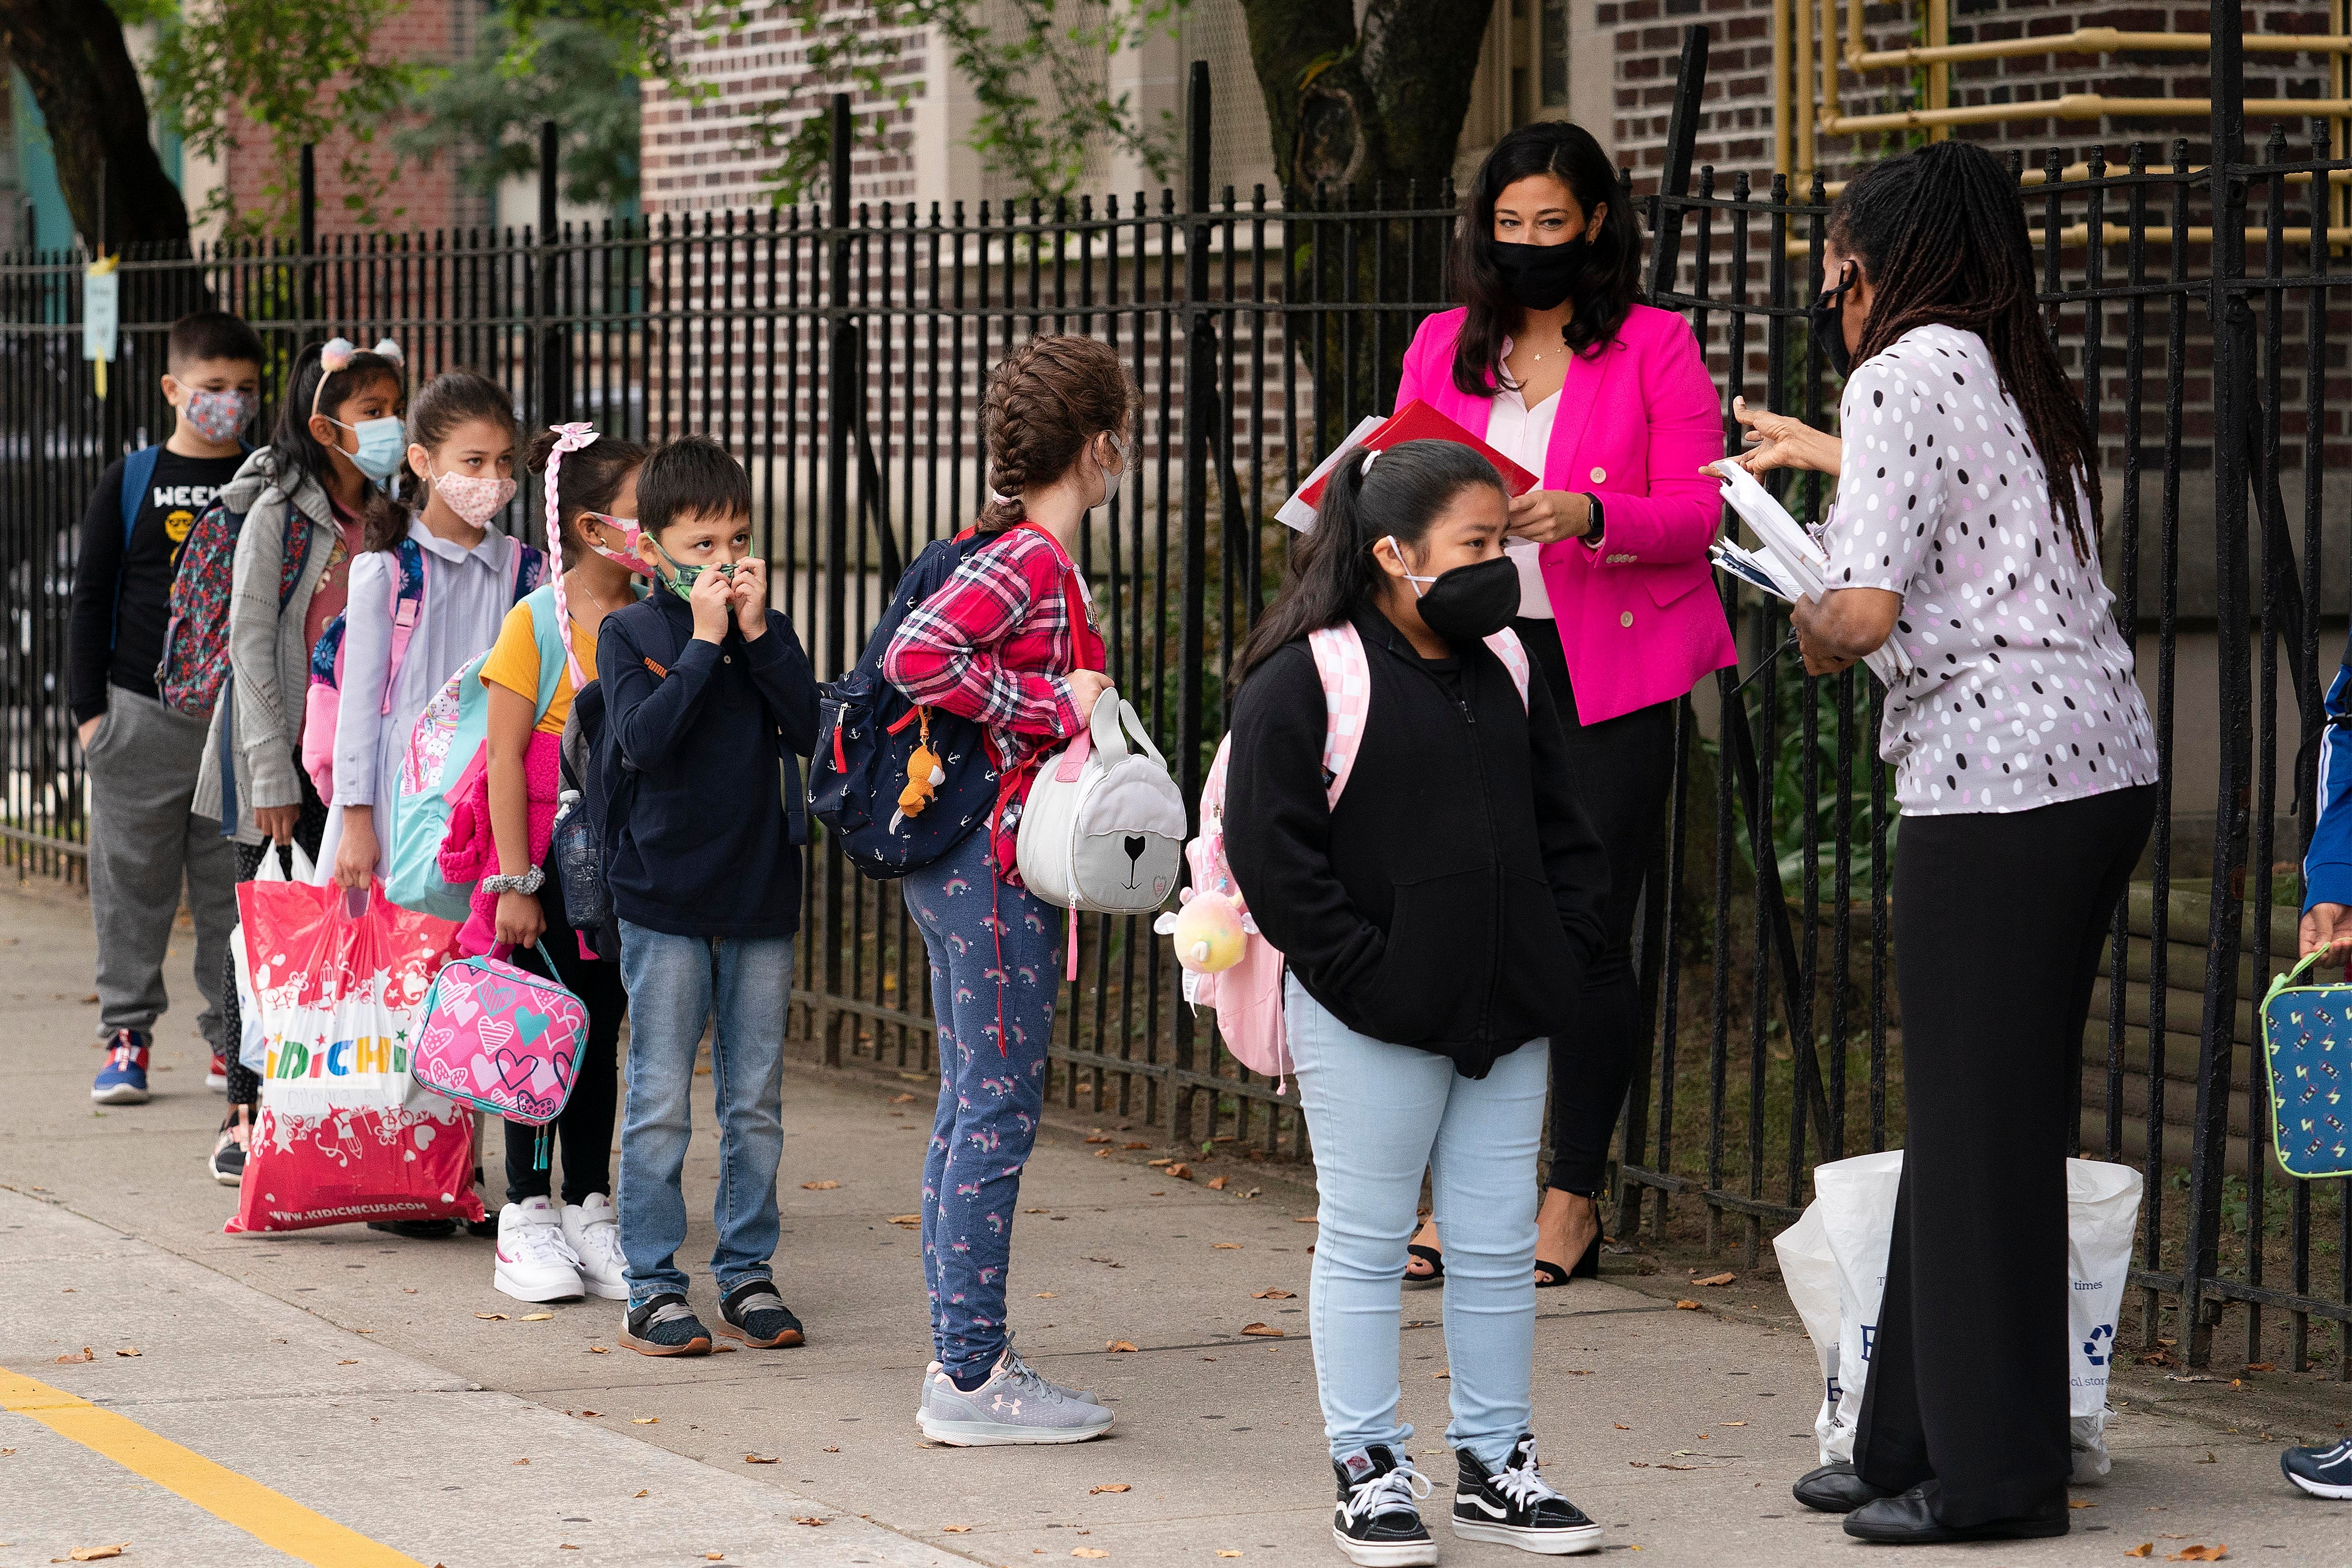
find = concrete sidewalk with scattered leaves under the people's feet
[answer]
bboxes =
[0,893,2352,1568]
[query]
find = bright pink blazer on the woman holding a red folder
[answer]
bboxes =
[1397,305,1738,724]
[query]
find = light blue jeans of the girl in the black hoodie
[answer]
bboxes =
[1284,980,1550,1469]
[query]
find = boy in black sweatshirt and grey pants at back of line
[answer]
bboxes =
[66,310,261,1105]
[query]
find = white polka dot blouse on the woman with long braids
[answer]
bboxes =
[1820,327,2157,816]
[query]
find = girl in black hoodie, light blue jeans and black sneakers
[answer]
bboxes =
[1225,442,1609,1566]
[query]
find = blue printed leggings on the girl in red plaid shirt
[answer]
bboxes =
[903,828,1068,1382]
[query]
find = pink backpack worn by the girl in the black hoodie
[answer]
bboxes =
[1183,623,1529,1093]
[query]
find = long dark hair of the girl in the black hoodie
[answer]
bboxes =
[1232,442,1503,684]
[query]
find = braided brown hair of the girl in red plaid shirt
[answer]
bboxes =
[978,334,1136,534]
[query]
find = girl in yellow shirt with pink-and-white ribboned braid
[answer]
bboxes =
[463,425,644,1302]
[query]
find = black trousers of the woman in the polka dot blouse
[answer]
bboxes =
[1853,785,2157,1526]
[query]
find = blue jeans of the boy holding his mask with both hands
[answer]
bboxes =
[619,919,793,1307]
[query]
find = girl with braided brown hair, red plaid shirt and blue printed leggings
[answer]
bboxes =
[882,336,1136,1446]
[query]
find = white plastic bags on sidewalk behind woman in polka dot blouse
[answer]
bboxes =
[1773,1149,2140,1483]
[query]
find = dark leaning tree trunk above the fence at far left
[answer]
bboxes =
[0,0,188,252]
